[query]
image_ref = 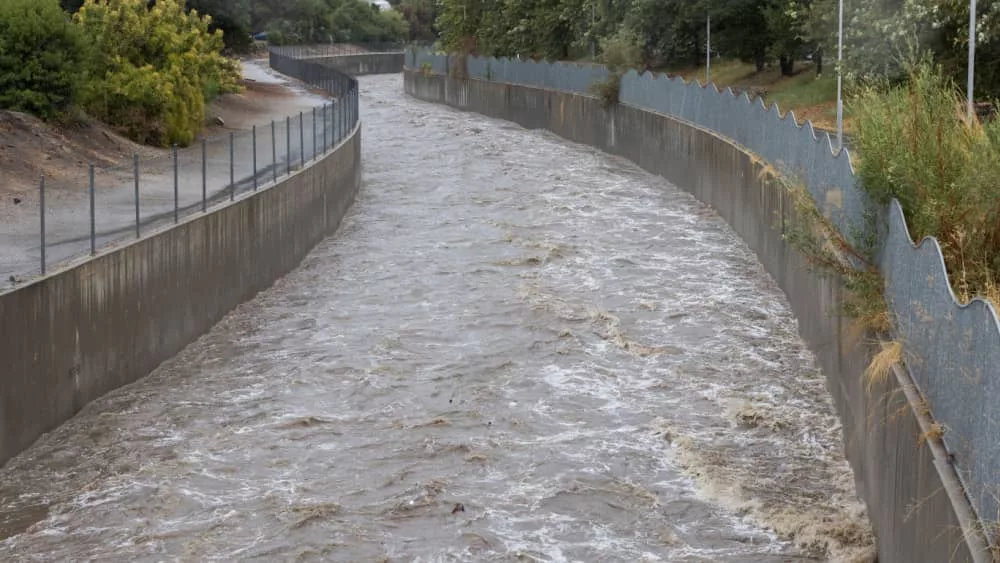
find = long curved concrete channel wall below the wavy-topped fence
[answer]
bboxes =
[405,70,981,562]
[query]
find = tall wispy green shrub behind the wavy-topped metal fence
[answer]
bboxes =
[853,55,1000,304]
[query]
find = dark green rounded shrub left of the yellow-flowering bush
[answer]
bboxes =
[0,0,83,119]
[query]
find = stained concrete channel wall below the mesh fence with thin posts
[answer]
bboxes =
[0,127,361,463]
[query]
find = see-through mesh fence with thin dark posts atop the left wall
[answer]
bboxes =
[0,52,358,288]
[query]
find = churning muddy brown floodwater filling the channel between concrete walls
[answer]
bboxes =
[0,75,874,561]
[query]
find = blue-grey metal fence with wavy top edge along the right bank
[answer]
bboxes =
[405,45,1000,520]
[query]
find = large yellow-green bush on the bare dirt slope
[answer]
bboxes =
[75,0,240,146]
